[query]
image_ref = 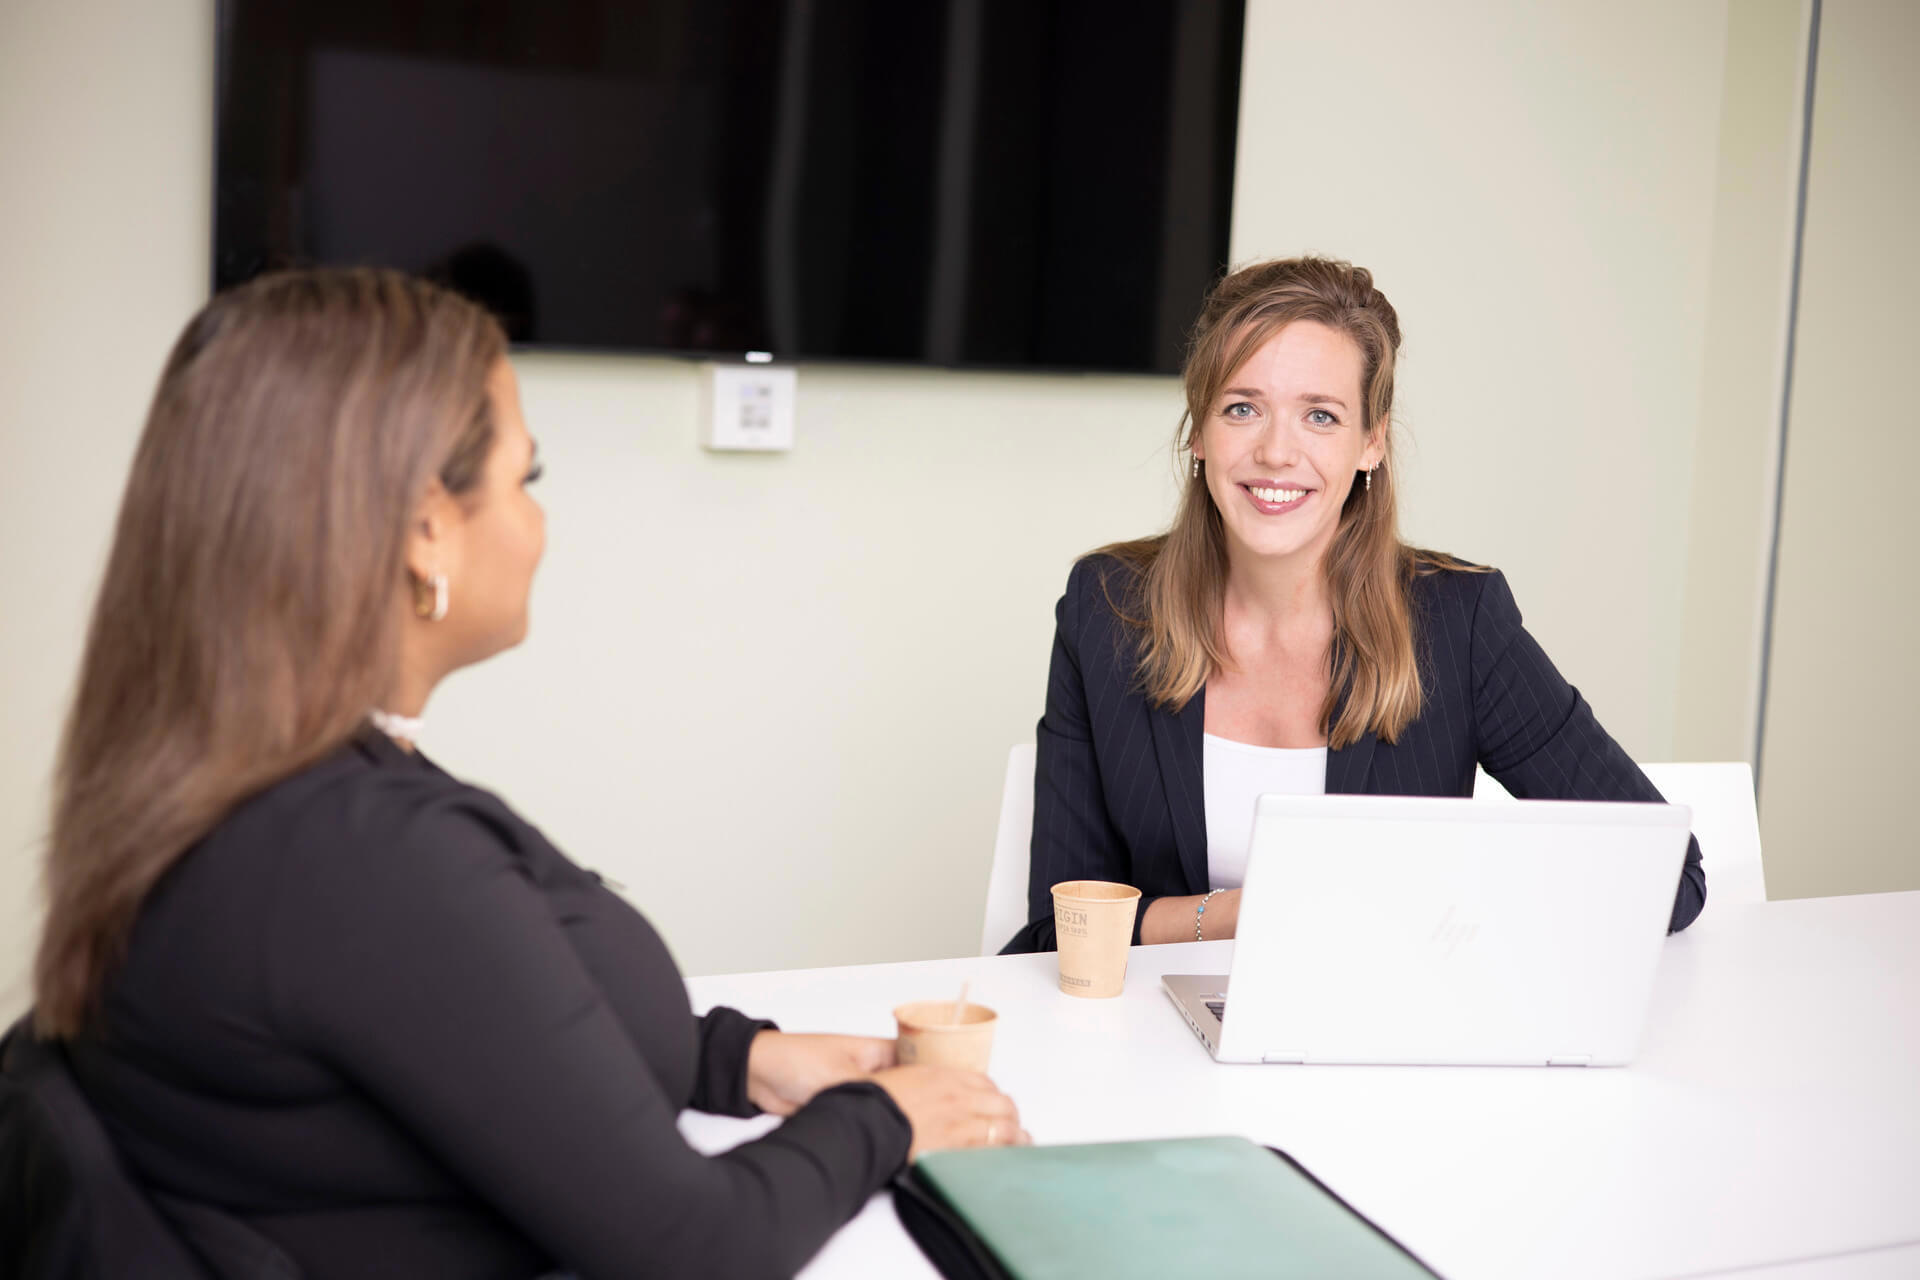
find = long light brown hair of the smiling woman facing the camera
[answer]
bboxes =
[1094,257,1475,748]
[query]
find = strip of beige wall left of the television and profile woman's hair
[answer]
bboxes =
[0,0,213,1017]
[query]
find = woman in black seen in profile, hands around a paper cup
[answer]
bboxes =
[22,271,1025,1278]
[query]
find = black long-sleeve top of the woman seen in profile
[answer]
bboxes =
[69,731,912,1280]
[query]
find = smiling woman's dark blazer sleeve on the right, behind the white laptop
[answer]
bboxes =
[1473,572,1707,933]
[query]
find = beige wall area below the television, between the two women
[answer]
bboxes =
[428,357,1179,971]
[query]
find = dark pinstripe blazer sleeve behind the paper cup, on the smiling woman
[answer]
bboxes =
[1000,560,1158,956]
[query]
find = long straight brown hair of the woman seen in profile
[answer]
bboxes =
[35,271,507,1036]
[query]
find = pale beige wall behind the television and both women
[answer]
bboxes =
[0,0,1812,1004]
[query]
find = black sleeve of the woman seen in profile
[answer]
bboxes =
[271,796,910,1280]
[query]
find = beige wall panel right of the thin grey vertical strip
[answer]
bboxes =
[1761,0,1920,898]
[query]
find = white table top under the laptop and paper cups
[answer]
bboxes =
[684,892,1920,1280]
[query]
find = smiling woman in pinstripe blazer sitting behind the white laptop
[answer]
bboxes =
[1006,257,1707,952]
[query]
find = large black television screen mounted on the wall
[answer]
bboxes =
[213,0,1244,372]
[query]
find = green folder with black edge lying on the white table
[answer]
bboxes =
[897,1138,1434,1280]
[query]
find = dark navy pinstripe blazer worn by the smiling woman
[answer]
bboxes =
[1004,557,1707,952]
